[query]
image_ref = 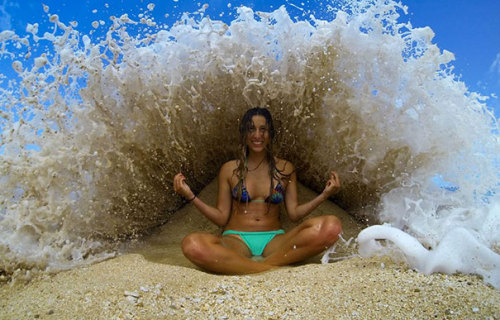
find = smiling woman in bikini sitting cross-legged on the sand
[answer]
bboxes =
[174,108,342,274]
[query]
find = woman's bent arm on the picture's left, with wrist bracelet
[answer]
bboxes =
[174,162,232,227]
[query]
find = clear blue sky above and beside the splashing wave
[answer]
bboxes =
[0,0,500,118]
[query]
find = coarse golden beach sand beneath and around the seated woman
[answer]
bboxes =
[0,183,500,319]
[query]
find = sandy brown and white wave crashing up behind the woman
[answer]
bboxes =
[0,1,500,288]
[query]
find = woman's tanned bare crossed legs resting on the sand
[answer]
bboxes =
[182,215,342,274]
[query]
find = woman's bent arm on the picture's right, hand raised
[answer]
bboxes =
[285,164,340,221]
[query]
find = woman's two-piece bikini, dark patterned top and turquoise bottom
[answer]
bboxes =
[222,181,285,256]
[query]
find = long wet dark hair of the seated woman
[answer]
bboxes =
[234,107,280,204]
